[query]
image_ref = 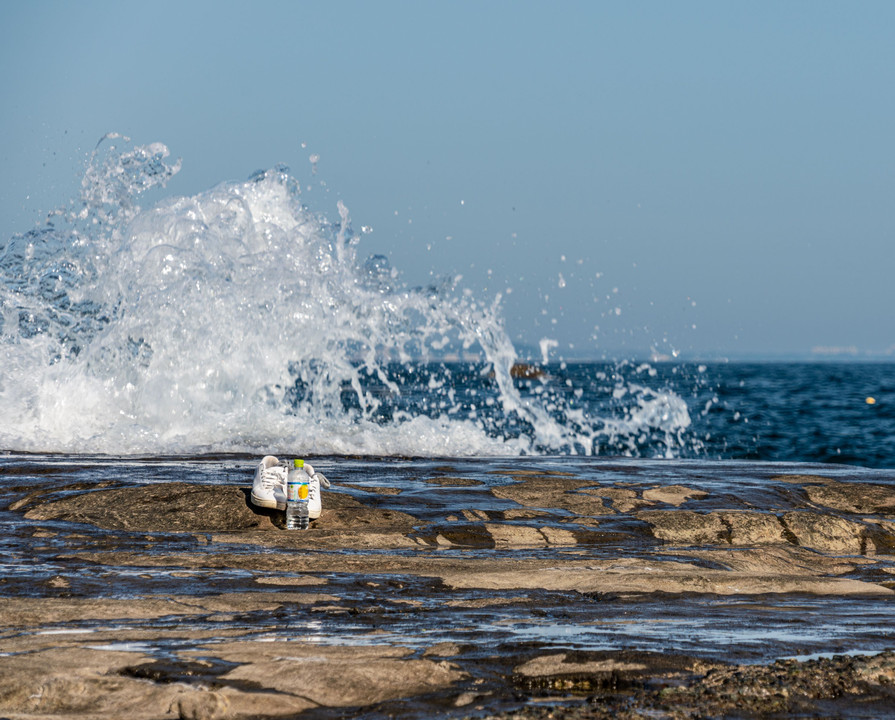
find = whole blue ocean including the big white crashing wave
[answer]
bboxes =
[0,135,895,468]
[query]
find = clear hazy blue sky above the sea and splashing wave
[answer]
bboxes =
[0,0,895,359]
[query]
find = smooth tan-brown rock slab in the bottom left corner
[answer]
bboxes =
[0,633,466,720]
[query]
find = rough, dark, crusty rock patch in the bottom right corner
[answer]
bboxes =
[479,653,895,720]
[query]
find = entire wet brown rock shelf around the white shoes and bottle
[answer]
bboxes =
[0,456,895,720]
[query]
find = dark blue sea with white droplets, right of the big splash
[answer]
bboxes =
[274,360,895,468]
